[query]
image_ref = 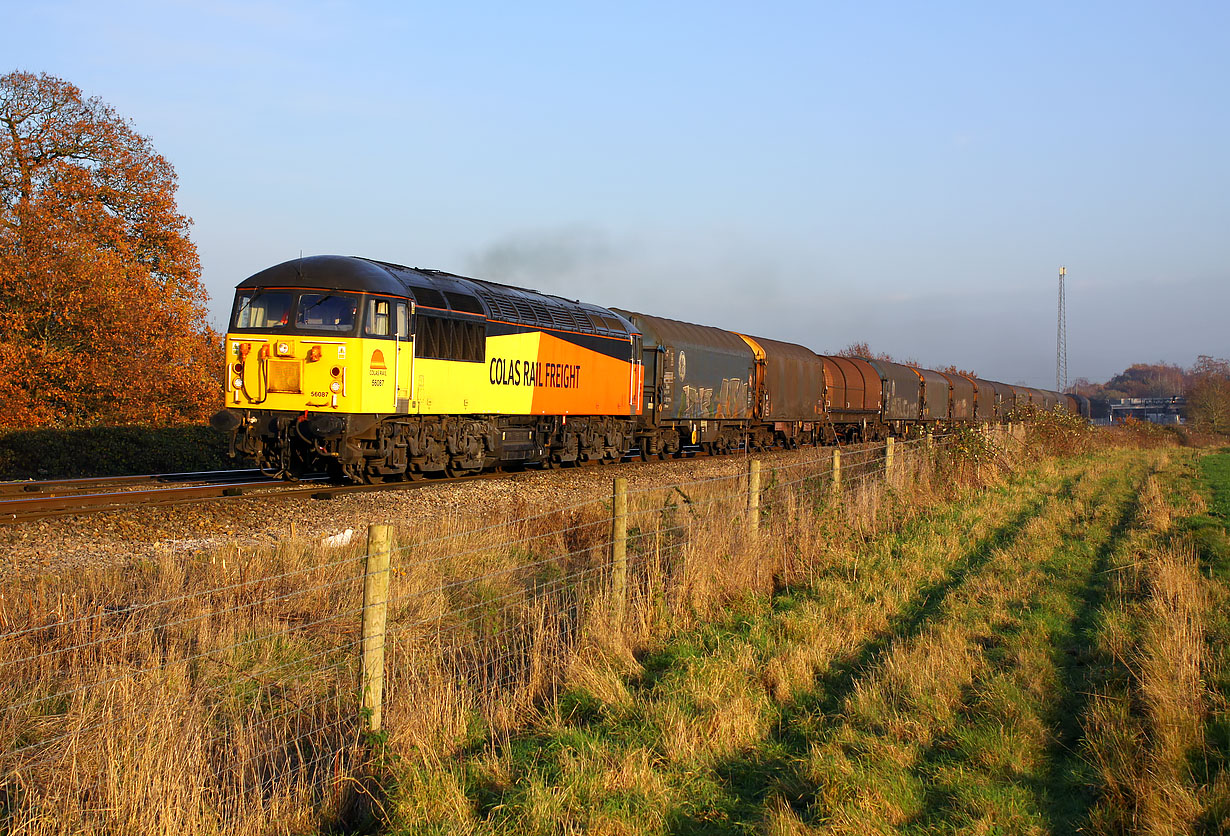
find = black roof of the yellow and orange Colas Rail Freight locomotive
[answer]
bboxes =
[237,256,638,337]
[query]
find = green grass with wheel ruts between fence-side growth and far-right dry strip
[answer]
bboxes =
[391,451,1180,835]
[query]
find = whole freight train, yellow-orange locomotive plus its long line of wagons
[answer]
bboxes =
[210,256,1089,483]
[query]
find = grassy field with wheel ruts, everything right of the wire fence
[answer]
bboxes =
[391,440,1230,834]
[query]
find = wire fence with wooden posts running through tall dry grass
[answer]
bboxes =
[0,427,1008,834]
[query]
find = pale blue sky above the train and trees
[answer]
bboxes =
[0,1,1230,386]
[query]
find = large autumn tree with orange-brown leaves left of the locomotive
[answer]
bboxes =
[0,73,221,427]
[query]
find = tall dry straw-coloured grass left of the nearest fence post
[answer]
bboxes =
[0,531,362,834]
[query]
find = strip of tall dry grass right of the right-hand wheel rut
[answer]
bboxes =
[1086,459,1215,836]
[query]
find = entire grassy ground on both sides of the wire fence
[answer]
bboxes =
[0,420,1230,834]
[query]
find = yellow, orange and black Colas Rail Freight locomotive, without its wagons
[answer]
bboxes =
[212,256,642,482]
